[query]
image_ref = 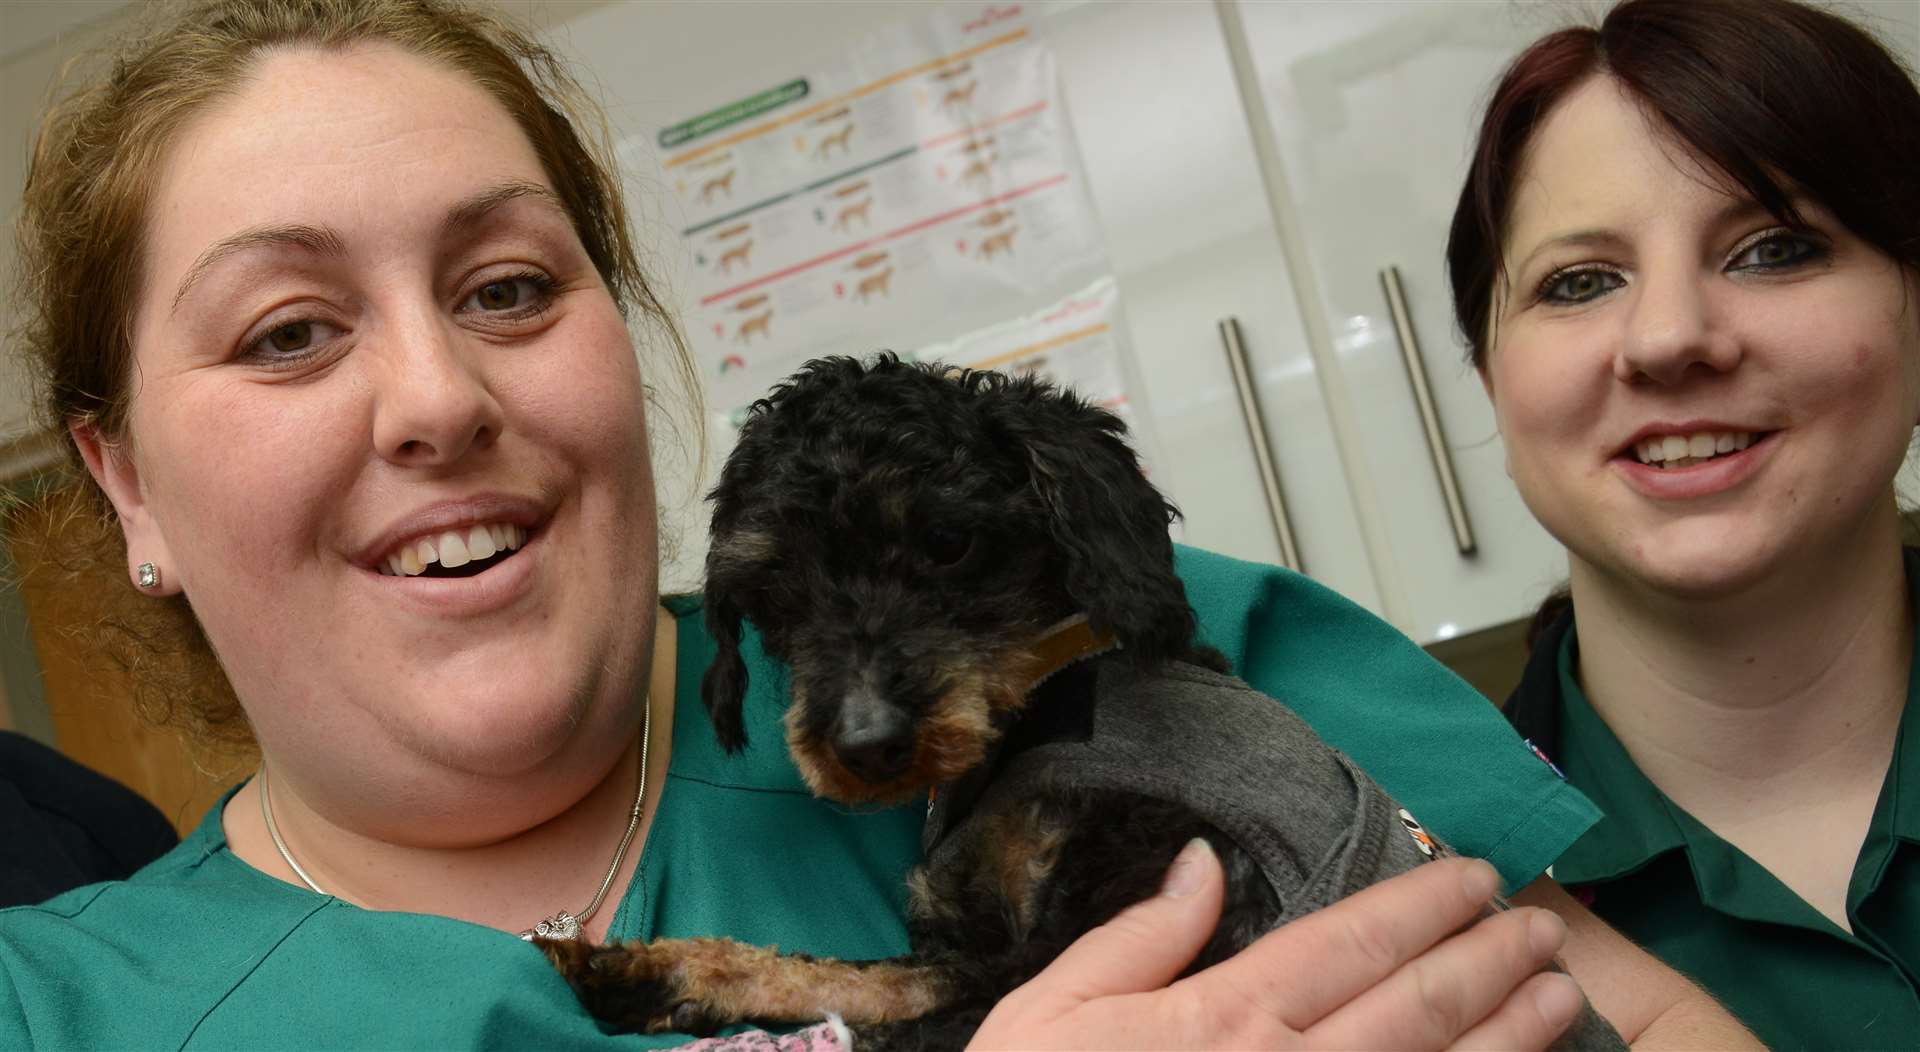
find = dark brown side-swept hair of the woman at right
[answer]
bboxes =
[1446,0,1920,367]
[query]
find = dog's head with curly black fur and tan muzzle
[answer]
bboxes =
[703,355,1219,801]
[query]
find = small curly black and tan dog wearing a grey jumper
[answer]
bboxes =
[543,355,1622,1050]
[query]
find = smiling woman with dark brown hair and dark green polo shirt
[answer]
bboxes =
[1448,0,1920,1048]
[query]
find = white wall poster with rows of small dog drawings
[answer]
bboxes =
[657,4,1127,424]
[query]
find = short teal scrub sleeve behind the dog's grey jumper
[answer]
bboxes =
[1175,547,1599,895]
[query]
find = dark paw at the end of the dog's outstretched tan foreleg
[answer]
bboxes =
[534,939,737,1037]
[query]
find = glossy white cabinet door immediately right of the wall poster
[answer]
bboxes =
[1041,4,1379,610]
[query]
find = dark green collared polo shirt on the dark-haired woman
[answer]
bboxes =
[1549,553,1920,1050]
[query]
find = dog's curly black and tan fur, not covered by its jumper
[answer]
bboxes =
[547,353,1277,1048]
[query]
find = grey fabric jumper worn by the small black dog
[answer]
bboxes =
[924,655,1626,1050]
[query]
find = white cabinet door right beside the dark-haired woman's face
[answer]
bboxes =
[1238,0,1567,643]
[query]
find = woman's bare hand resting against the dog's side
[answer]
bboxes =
[972,841,1580,1048]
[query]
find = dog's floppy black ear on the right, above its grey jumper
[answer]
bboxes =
[985,378,1194,662]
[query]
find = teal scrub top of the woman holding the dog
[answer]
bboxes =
[0,549,1597,1050]
